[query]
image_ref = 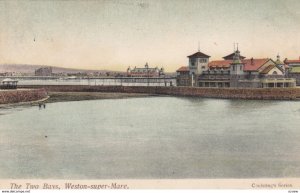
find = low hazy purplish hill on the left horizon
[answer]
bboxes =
[0,64,117,73]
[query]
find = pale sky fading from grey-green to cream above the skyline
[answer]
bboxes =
[0,0,300,72]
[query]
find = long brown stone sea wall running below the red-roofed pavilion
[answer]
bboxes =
[18,85,300,100]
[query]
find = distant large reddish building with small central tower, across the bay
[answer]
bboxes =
[127,63,164,77]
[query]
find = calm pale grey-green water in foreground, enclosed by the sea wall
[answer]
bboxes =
[0,97,300,179]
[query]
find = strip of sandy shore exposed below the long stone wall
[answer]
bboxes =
[45,92,156,103]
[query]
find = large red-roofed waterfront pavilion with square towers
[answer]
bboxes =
[176,48,300,88]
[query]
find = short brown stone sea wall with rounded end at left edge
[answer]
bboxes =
[0,88,48,104]
